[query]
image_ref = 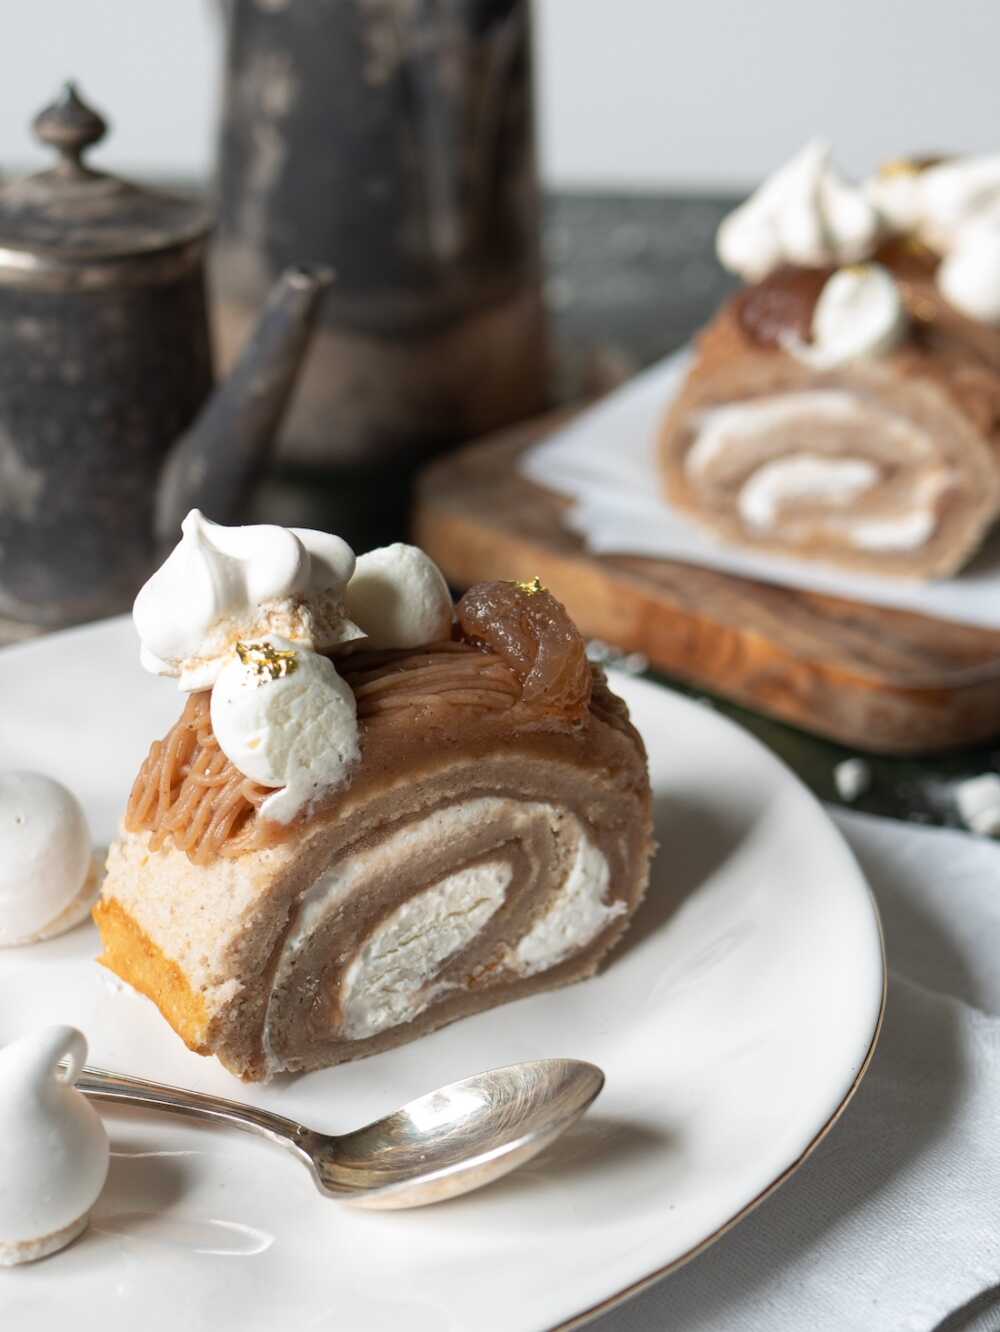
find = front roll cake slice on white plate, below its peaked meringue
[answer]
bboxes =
[95,519,652,1080]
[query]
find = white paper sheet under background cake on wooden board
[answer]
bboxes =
[521,352,1000,629]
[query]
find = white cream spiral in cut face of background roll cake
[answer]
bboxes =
[684,389,953,551]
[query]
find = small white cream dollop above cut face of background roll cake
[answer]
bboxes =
[783,264,909,369]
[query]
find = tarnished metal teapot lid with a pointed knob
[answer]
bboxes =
[0,83,212,281]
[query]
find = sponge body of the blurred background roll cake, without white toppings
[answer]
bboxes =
[660,244,1000,578]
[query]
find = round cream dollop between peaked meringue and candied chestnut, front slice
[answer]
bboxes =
[344,542,453,647]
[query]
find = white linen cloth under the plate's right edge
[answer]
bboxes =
[594,810,1000,1332]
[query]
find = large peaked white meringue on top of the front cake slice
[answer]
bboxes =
[132,509,360,690]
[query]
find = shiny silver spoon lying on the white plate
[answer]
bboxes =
[76,1059,605,1209]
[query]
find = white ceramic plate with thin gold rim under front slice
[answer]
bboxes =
[0,621,884,1332]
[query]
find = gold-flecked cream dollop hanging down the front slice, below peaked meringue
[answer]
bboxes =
[209,634,361,823]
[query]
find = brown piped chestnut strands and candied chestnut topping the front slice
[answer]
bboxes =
[125,582,609,864]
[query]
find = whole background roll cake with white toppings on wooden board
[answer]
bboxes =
[660,144,1000,578]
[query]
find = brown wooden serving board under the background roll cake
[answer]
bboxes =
[414,413,1000,754]
